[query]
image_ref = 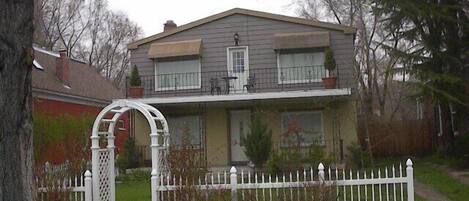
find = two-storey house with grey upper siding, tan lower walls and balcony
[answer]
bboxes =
[128,8,357,166]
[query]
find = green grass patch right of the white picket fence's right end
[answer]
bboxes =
[414,162,469,201]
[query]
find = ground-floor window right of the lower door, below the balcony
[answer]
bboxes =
[281,111,324,147]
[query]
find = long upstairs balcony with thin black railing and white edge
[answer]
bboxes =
[125,65,351,104]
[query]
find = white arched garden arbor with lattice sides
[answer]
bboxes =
[91,100,169,201]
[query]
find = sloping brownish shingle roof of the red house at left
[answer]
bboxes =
[32,47,124,102]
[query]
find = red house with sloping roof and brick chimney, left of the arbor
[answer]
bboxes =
[32,46,129,163]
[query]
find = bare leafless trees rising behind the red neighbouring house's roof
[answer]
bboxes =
[37,0,142,88]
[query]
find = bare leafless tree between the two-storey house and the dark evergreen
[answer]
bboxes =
[294,0,407,163]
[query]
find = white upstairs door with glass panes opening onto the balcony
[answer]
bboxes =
[228,47,249,93]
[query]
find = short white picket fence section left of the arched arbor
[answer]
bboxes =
[36,170,92,201]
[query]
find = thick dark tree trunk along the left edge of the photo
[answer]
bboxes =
[0,0,36,201]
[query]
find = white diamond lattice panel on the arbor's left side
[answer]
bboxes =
[98,149,111,201]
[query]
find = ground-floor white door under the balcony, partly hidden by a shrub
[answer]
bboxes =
[230,110,251,163]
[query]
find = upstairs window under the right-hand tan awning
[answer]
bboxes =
[277,52,326,84]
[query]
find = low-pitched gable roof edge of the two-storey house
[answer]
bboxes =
[127,8,356,49]
